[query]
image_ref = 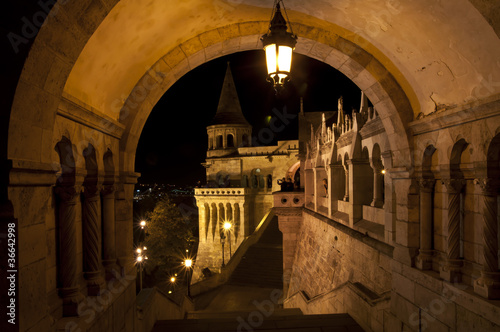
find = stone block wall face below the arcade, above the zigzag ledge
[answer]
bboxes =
[288,210,392,304]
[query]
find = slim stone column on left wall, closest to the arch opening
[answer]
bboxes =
[101,185,119,280]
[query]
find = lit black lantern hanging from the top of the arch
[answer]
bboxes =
[261,0,297,93]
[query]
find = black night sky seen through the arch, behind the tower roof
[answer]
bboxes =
[135,51,361,186]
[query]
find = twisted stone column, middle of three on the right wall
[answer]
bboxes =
[440,179,465,282]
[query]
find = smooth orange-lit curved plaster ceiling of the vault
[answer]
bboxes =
[65,0,500,119]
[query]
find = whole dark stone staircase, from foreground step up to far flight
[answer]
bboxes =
[152,217,363,332]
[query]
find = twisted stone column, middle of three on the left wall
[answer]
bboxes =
[82,185,103,296]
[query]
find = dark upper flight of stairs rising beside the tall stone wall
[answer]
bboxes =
[229,217,283,290]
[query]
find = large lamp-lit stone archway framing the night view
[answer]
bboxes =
[5,0,500,329]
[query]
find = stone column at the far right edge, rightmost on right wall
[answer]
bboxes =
[474,178,500,300]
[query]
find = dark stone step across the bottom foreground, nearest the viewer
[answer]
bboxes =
[152,311,363,332]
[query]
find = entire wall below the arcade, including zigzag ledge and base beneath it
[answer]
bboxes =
[280,209,392,331]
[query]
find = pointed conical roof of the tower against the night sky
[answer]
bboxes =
[210,62,250,126]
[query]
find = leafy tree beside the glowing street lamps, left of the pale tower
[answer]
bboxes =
[144,197,198,281]
